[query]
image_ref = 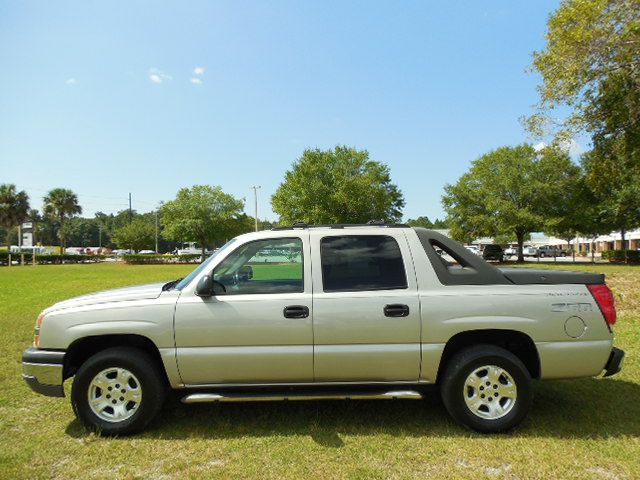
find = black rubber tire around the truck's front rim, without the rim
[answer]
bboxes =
[71,347,168,436]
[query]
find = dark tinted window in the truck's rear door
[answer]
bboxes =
[320,235,407,292]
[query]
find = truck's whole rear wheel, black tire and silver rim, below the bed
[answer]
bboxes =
[440,345,533,433]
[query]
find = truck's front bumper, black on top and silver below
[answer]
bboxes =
[22,348,65,397]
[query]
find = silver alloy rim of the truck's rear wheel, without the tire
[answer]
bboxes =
[463,365,518,420]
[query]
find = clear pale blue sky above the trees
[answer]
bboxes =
[0,0,558,218]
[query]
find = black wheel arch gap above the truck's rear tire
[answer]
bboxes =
[436,329,540,382]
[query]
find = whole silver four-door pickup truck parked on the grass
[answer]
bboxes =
[22,224,624,435]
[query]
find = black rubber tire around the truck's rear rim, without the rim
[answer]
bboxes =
[439,345,533,433]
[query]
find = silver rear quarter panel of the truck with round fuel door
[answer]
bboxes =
[410,231,613,382]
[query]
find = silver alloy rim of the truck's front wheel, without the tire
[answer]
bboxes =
[88,367,142,423]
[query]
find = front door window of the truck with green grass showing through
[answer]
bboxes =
[213,238,304,295]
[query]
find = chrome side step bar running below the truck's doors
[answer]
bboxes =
[182,390,422,403]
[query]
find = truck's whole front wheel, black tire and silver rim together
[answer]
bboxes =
[71,347,167,435]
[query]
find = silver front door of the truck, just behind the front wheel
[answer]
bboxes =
[175,234,313,385]
